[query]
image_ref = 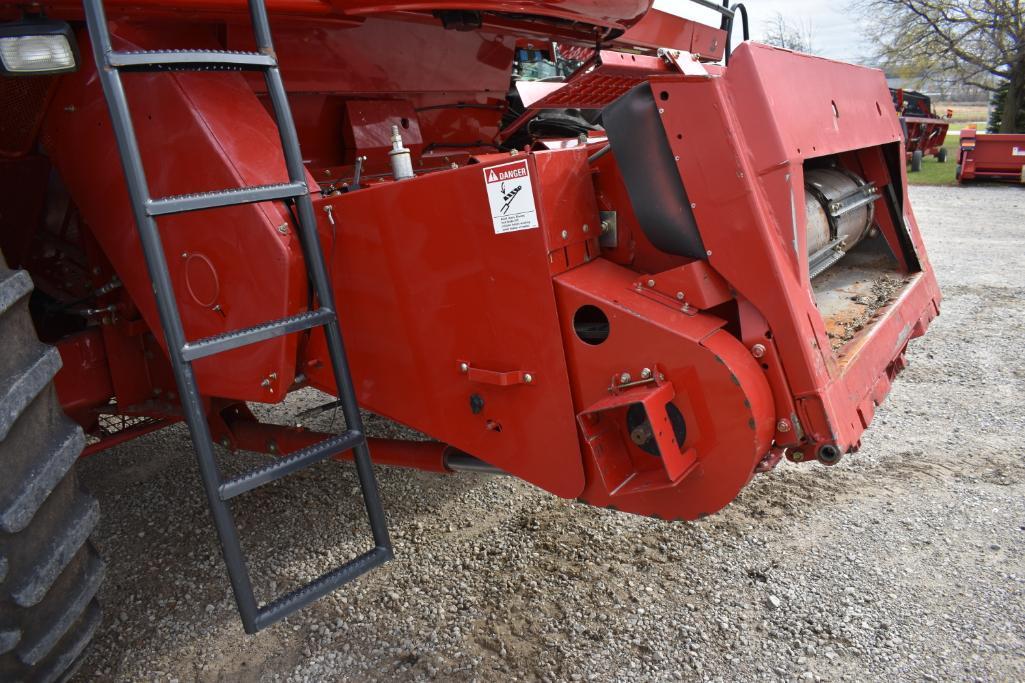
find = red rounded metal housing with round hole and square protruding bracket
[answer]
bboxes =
[557,259,774,519]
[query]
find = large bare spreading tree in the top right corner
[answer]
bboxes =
[859,0,1025,132]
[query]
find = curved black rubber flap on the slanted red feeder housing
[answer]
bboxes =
[602,83,706,258]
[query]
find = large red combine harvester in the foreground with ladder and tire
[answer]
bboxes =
[0,0,940,680]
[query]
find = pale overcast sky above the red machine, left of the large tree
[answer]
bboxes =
[655,0,871,62]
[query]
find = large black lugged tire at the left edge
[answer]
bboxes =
[0,254,104,683]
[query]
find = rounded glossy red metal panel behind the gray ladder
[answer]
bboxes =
[43,27,306,402]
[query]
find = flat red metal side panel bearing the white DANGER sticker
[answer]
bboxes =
[308,151,598,497]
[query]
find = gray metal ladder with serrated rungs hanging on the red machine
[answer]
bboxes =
[83,0,393,633]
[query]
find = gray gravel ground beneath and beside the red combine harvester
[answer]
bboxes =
[74,186,1025,681]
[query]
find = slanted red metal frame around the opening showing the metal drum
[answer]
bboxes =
[652,43,939,451]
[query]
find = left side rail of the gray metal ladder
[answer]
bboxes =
[84,0,256,633]
